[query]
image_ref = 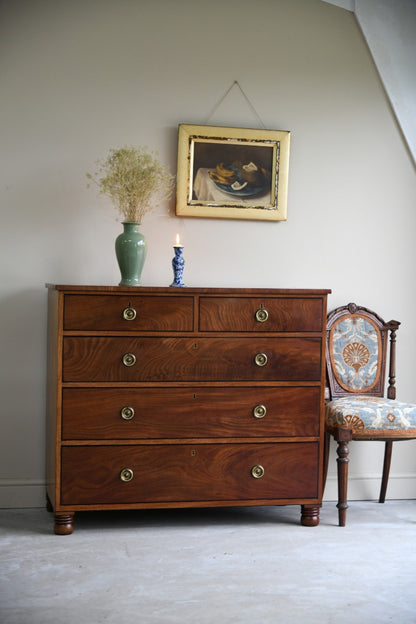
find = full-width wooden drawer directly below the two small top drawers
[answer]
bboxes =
[63,336,321,382]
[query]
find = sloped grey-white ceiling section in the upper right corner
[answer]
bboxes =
[323,0,416,164]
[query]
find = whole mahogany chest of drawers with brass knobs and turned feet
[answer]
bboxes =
[47,285,330,535]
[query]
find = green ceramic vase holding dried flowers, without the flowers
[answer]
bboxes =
[116,221,147,286]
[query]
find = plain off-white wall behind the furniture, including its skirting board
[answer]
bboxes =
[0,0,416,506]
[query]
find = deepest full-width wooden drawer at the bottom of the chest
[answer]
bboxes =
[61,442,319,505]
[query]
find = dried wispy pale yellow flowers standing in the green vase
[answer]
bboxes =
[87,147,175,223]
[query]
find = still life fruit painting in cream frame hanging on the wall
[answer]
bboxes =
[176,124,290,221]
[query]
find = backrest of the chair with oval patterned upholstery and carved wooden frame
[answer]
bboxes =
[326,303,396,399]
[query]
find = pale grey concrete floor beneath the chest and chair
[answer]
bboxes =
[0,500,416,624]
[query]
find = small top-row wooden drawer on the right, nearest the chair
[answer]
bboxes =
[199,297,323,332]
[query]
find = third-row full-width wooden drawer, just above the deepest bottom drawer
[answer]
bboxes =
[62,386,320,440]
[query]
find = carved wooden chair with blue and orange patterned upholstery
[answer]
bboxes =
[324,303,416,526]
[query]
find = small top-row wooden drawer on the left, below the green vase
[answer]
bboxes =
[64,295,194,332]
